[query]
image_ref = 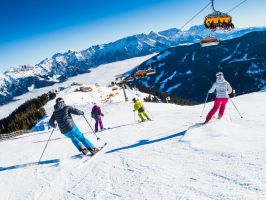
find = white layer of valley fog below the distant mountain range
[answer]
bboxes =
[0,54,156,119]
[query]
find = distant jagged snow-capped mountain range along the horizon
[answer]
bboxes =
[0,26,265,104]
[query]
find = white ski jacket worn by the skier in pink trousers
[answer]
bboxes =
[209,77,232,98]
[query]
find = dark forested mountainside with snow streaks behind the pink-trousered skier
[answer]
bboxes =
[131,31,266,102]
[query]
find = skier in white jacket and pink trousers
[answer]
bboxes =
[204,72,232,123]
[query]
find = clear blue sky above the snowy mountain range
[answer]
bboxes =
[0,0,266,72]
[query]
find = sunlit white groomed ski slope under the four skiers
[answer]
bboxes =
[0,83,266,200]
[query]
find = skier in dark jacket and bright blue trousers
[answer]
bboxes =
[49,97,99,155]
